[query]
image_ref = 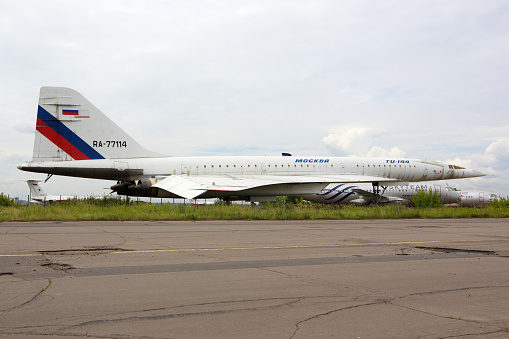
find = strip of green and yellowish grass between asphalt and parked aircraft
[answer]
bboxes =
[0,201,509,222]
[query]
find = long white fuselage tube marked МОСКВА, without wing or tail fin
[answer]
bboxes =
[20,156,480,182]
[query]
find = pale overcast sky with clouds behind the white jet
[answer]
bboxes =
[0,0,509,198]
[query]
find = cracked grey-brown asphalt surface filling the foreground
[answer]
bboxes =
[0,219,509,339]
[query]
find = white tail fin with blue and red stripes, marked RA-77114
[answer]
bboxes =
[32,87,165,162]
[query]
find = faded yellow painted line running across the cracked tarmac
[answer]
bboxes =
[0,238,509,257]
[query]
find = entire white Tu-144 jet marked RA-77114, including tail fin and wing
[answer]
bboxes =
[18,87,484,201]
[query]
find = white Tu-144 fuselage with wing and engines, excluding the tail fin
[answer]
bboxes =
[20,156,482,201]
